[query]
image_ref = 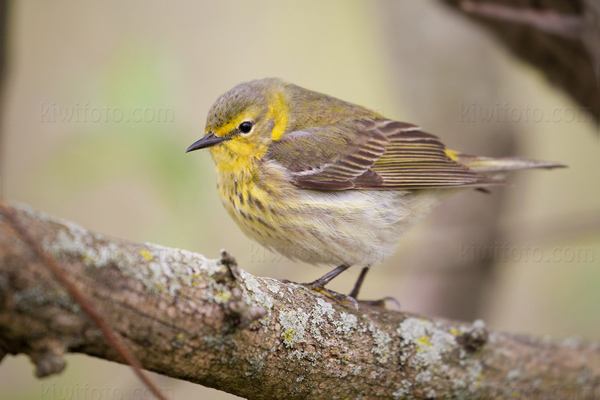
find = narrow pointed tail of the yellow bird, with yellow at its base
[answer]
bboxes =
[446,150,566,172]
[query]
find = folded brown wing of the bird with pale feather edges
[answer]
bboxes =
[268,119,503,190]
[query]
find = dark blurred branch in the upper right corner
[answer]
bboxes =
[443,0,600,122]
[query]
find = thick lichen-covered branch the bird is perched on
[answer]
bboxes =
[0,207,600,399]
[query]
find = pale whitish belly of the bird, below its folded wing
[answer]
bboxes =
[249,190,439,266]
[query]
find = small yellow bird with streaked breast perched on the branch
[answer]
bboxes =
[186,78,564,304]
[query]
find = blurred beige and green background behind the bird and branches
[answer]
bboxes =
[0,0,600,399]
